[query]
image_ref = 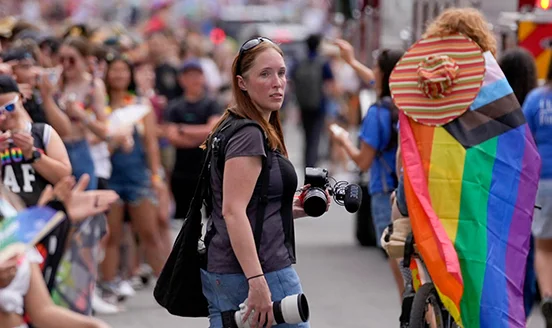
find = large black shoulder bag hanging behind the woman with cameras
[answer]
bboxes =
[153,115,271,317]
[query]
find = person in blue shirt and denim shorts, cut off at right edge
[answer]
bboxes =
[523,60,552,327]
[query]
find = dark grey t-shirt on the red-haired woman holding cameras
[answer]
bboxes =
[207,126,297,273]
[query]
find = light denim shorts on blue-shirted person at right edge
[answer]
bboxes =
[531,179,552,239]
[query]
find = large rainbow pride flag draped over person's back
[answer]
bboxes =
[400,52,541,328]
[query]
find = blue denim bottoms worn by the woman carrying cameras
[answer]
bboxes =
[201,267,310,328]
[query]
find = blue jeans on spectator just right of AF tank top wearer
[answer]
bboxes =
[65,140,98,190]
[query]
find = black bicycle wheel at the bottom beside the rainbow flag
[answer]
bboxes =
[410,283,449,328]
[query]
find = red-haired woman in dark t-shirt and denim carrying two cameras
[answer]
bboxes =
[201,38,328,328]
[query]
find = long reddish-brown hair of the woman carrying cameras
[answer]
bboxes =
[205,42,287,157]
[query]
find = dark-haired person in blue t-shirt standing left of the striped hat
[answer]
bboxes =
[332,46,404,297]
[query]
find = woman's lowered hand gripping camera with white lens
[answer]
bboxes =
[243,276,274,328]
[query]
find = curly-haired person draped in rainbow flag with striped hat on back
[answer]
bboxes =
[389,8,541,328]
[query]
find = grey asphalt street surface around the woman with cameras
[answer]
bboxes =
[100,111,544,328]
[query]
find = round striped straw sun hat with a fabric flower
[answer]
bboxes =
[389,33,485,126]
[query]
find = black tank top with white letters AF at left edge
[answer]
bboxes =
[0,123,52,206]
